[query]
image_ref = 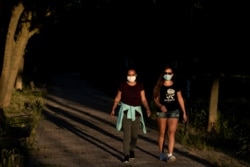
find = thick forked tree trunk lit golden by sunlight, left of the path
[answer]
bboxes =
[0,2,38,107]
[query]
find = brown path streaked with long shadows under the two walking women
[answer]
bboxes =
[26,73,248,167]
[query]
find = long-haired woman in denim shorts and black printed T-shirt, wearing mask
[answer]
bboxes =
[153,66,187,162]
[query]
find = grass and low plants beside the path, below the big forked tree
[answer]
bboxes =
[0,89,46,167]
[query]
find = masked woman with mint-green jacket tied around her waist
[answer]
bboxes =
[111,68,151,163]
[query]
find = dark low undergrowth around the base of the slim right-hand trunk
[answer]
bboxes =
[176,97,250,162]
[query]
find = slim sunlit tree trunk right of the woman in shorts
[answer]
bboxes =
[207,76,220,132]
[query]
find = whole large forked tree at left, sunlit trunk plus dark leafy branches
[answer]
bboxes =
[0,0,82,108]
